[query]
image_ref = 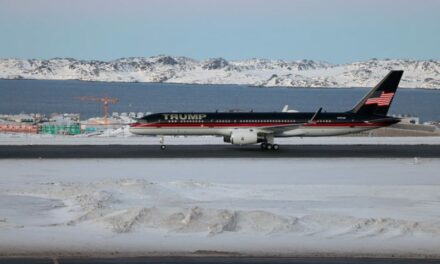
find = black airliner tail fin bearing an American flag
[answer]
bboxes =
[351,71,403,115]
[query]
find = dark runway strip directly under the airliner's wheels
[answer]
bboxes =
[0,145,440,159]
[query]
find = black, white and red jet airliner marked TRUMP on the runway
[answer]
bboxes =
[129,71,403,150]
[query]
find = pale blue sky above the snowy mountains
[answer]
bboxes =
[0,0,440,63]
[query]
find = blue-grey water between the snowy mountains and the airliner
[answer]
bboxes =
[0,80,440,121]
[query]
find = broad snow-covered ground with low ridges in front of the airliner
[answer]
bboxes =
[0,159,440,256]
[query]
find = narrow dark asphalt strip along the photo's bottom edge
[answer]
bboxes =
[0,257,440,264]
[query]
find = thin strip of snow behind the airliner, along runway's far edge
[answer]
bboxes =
[0,132,440,147]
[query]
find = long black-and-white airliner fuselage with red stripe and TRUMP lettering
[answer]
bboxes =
[130,112,399,137]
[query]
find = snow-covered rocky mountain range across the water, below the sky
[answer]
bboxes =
[0,55,440,89]
